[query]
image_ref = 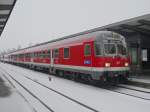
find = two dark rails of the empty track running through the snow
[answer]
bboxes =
[1,68,100,112]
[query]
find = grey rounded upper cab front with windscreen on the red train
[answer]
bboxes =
[94,32,127,57]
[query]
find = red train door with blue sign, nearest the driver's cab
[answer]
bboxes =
[84,42,92,68]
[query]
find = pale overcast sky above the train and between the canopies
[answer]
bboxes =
[0,0,150,51]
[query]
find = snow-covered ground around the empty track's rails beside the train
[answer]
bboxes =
[0,63,150,112]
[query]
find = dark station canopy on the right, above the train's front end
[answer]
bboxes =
[79,14,150,35]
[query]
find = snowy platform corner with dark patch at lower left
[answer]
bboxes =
[0,73,33,112]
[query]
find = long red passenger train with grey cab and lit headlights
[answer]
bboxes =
[1,31,130,81]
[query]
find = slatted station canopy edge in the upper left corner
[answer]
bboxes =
[0,0,16,36]
